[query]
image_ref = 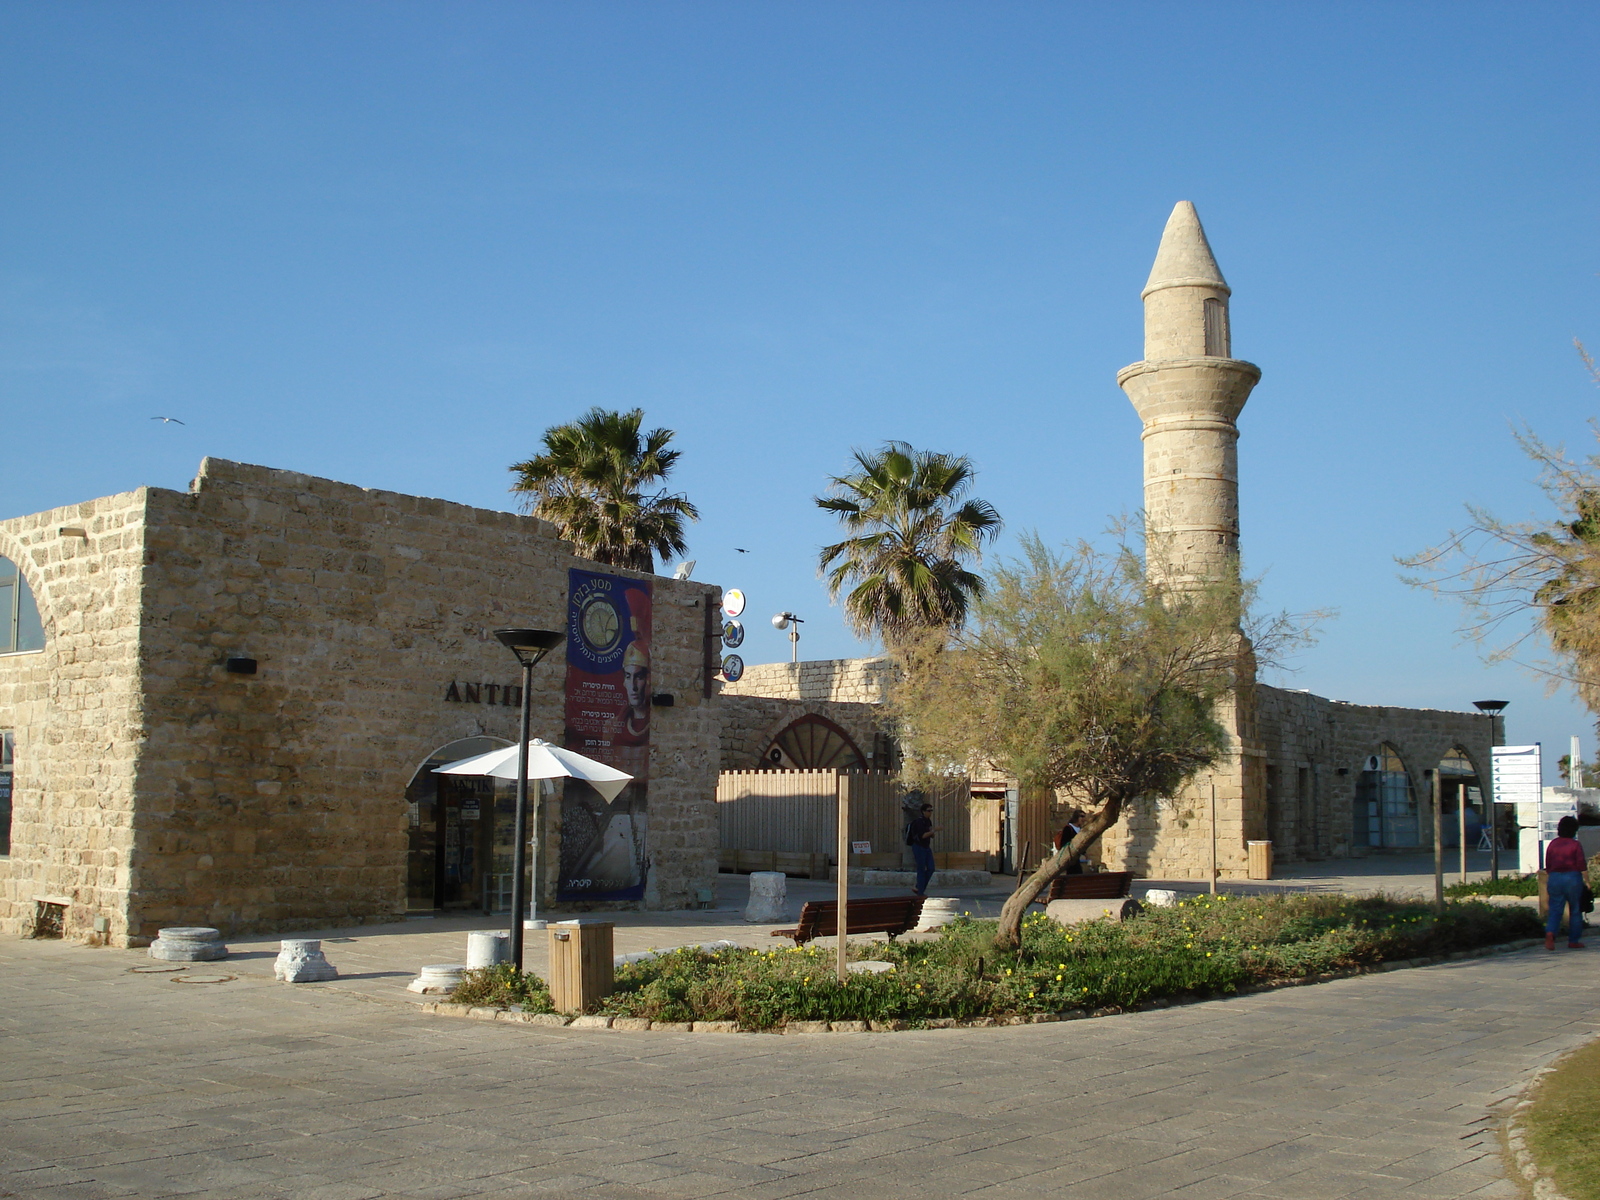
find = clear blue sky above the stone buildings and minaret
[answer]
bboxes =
[0,0,1600,780]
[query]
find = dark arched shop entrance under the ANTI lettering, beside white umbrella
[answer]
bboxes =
[405,738,515,912]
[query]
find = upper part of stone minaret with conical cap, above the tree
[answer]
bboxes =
[1117,200,1261,595]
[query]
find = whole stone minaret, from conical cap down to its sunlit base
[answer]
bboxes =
[1106,200,1266,878]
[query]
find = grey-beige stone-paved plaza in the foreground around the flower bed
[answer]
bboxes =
[0,857,1600,1200]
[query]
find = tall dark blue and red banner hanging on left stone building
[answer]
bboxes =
[557,568,651,901]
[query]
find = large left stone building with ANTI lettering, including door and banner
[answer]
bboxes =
[0,459,720,946]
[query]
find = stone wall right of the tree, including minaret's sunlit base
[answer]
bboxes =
[1104,685,1491,878]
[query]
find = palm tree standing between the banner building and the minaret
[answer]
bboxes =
[816,442,1000,645]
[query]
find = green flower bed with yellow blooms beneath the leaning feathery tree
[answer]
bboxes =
[451,896,1539,1030]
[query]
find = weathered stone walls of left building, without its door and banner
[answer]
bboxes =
[0,459,718,941]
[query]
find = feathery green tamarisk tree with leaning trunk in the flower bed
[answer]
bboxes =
[891,536,1296,949]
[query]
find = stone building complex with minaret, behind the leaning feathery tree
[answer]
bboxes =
[723,202,1493,878]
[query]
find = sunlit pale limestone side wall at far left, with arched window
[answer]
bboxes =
[0,490,146,938]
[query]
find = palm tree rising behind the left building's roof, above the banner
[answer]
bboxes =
[510,408,699,571]
